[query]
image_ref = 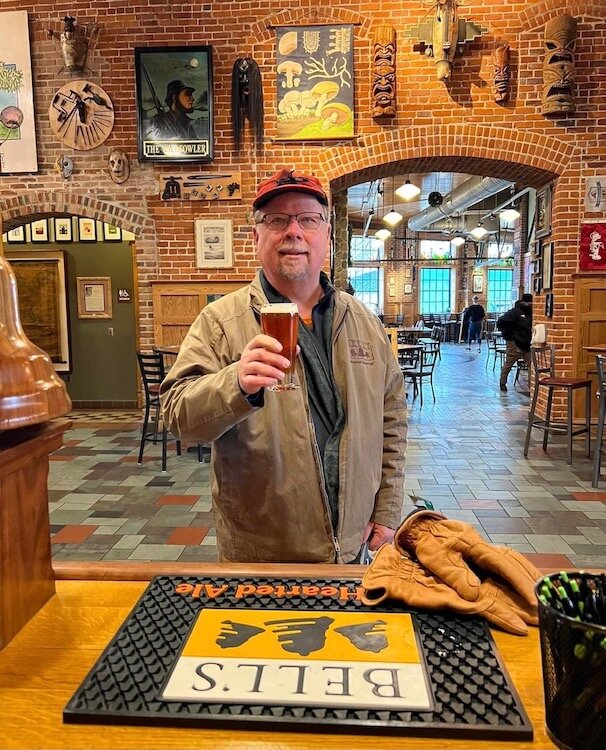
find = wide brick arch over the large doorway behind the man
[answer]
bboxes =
[317,124,582,191]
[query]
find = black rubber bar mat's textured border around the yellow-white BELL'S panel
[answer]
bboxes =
[63,576,533,741]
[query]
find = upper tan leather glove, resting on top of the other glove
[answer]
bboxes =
[394,510,541,610]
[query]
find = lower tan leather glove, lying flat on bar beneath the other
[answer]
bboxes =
[362,544,538,635]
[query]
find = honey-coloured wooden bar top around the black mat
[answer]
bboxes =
[0,563,554,750]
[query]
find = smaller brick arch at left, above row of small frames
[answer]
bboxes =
[0,190,154,237]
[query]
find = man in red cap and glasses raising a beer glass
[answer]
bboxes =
[161,169,406,562]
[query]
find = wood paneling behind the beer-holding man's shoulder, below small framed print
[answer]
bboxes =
[152,281,247,346]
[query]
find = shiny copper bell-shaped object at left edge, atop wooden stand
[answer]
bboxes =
[0,230,72,432]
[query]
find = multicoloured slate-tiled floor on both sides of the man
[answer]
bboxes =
[49,344,606,568]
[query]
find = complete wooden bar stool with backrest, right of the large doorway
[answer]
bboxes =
[524,344,591,464]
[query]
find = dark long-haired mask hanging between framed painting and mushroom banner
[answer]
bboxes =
[231,57,264,151]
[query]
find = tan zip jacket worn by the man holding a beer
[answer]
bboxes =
[161,275,407,562]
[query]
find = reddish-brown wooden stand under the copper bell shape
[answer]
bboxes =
[0,420,71,650]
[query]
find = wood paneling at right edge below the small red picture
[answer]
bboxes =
[574,273,606,419]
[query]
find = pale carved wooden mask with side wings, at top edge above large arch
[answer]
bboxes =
[404,0,487,81]
